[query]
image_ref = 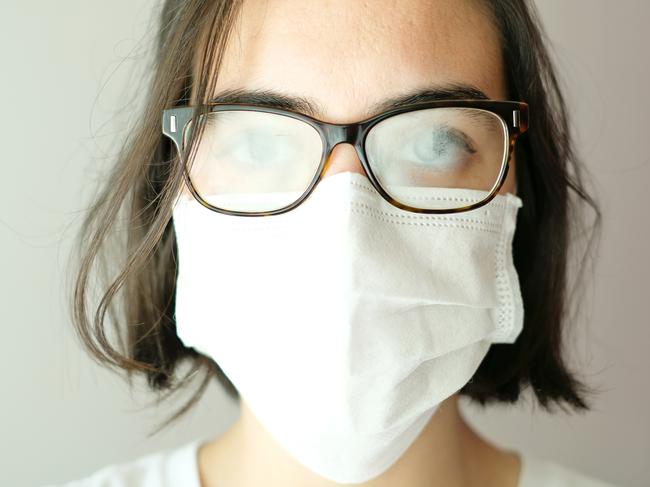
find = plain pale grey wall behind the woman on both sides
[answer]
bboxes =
[0,0,650,487]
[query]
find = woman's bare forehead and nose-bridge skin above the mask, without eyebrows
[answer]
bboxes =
[205,0,515,193]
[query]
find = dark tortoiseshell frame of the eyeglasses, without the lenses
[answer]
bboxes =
[162,100,528,216]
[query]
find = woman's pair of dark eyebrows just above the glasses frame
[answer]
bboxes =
[210,83,489,119]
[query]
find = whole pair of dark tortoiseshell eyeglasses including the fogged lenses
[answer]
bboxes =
[162,100,528,216]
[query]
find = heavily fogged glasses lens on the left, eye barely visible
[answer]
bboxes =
[184,110,323,212]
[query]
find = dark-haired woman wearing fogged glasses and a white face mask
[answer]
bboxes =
[54,0,605,487]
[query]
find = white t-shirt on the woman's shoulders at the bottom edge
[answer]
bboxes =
[44,439,617,487]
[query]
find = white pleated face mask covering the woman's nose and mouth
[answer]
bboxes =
[173,172,523,483]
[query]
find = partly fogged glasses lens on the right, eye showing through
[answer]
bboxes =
[365,107,508,209]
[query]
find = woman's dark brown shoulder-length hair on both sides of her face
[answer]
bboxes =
[72,0,600,432]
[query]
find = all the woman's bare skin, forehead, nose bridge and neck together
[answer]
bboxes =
[198,0,521,487]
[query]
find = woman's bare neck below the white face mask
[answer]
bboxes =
[199,394,519,487]
